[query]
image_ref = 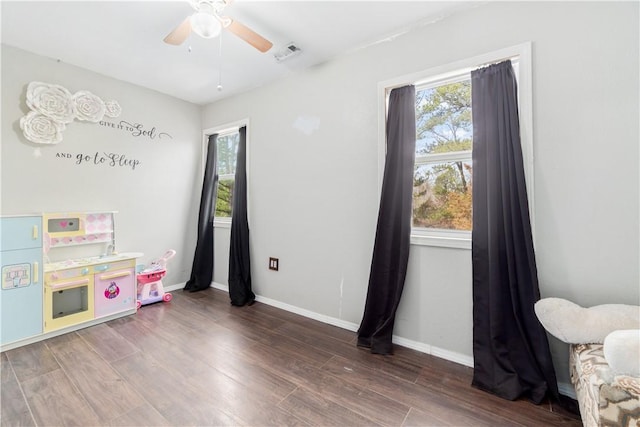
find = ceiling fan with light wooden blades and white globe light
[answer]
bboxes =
[164,0,273,52]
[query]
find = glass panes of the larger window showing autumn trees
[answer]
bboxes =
[413,77,473,231]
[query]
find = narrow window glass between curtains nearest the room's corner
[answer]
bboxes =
[215,130,240,220]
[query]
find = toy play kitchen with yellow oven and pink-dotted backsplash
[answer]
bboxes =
[0,212,143,351]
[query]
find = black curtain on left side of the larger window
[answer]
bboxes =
[358,86,416,354]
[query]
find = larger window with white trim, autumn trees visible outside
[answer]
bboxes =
[378,43,535,249]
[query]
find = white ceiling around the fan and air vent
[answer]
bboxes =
[1,0,477,104]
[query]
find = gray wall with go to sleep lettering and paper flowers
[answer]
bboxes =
[0,45,202,284]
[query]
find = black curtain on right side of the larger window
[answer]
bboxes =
[471,61,558,403]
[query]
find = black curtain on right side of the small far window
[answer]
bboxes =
[229,126,256,306]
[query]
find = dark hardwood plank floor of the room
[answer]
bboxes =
[0,289,581,426]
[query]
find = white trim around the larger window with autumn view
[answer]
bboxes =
[378,42,535,249]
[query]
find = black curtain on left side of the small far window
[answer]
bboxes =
[184,134,218,292]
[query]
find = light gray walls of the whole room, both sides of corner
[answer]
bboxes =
[0,2,640,398]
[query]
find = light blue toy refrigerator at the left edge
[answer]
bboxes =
[0,217,43,345]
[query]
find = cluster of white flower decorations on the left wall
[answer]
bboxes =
[20,82,122,144]
